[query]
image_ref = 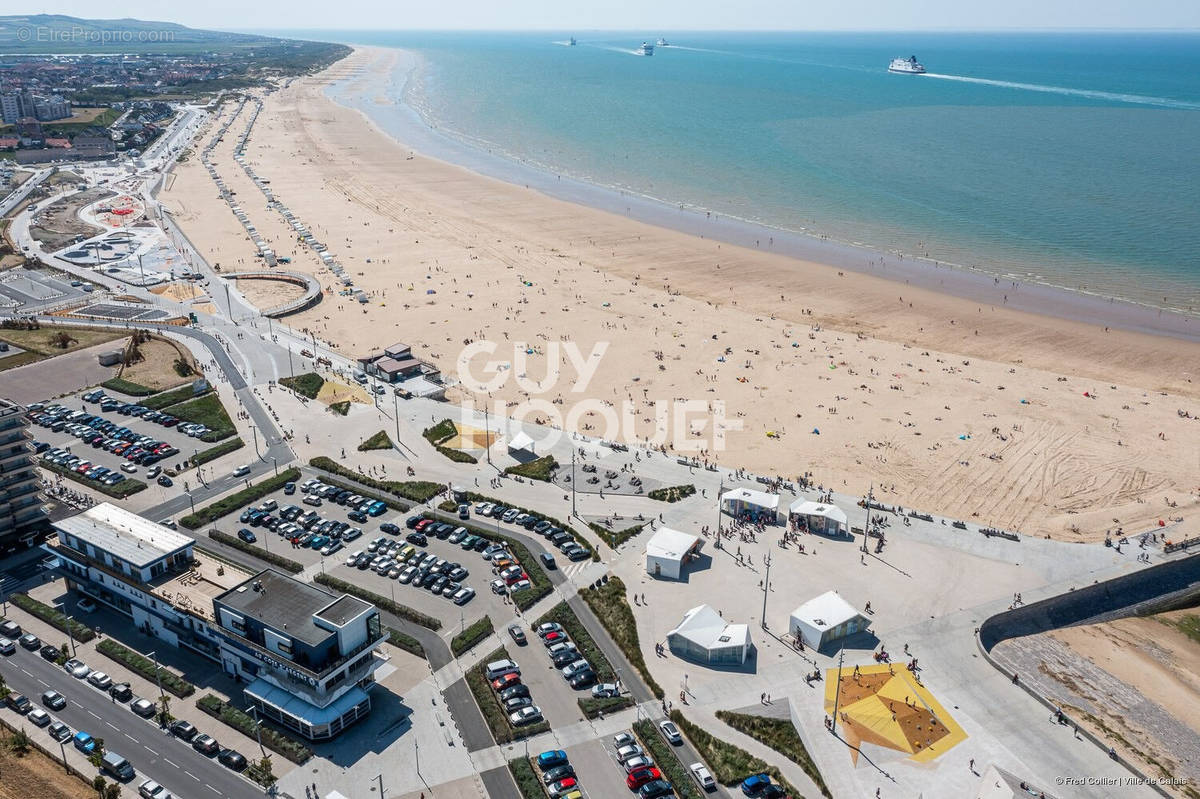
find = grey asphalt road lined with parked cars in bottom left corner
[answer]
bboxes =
[0,648,263,799]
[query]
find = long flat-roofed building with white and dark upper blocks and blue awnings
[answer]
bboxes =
[46,503,384,740]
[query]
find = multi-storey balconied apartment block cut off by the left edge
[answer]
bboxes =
[0,400,49,552]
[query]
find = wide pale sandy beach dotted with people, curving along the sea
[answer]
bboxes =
[161,44,1200,540]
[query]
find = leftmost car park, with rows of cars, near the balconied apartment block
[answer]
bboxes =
[30,390,241,504]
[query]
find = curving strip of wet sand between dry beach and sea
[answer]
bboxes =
[324,44,1200,342]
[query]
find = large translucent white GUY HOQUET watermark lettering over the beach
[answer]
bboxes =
[456,341,742,453]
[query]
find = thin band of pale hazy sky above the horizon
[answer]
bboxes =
[16,0,1200,32]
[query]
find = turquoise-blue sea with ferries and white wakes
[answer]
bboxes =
[272,31,1200,316]
